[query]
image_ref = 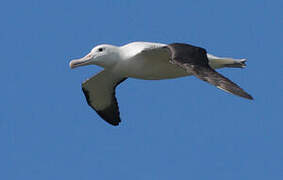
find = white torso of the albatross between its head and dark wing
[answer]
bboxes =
[114,42,189,80]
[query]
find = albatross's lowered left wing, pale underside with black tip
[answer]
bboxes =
[82,70,127,126]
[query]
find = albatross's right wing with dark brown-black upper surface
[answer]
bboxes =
[168,43,253,99]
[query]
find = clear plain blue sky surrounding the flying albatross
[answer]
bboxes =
[0,0,283,180]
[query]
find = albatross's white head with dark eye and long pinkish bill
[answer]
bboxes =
[69,44,119,69]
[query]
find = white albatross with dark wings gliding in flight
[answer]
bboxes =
[69,42,253,126]
